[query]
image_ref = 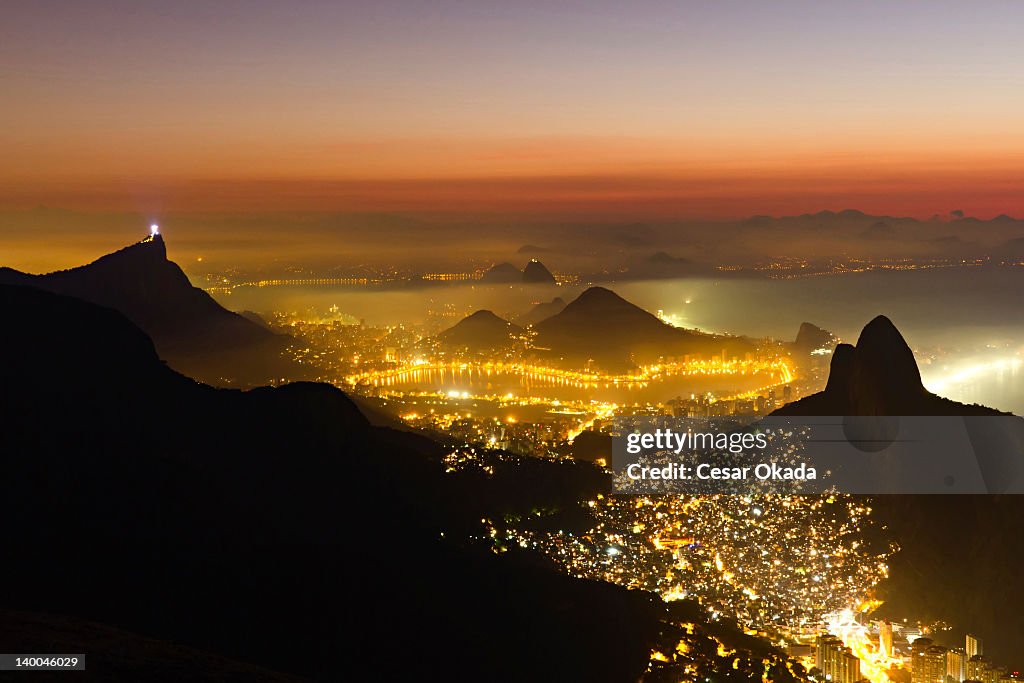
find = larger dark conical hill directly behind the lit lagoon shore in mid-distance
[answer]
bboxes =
[534,287,746,369]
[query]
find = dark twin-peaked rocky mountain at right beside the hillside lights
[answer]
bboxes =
[773,315,1024,661]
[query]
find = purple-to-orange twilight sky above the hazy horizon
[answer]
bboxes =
[0,0,1024,218]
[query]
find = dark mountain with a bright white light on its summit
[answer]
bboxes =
[0,234,295,384]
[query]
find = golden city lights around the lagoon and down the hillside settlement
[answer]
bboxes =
[253,290,1012,683]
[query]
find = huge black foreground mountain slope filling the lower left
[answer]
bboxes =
[0,286,665,680]
